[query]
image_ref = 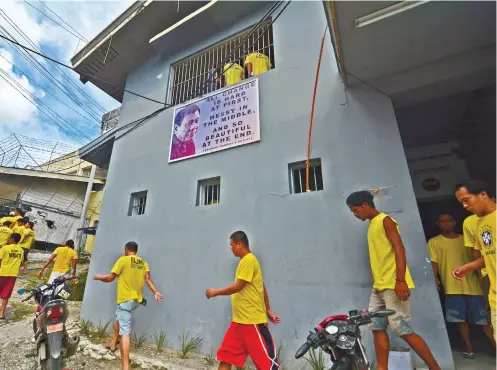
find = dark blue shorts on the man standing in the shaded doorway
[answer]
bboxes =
[445,294,488,325]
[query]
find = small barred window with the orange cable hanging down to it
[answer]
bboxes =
[288,159,324,194]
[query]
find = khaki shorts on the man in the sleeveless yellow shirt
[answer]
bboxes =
[369,289,414,337]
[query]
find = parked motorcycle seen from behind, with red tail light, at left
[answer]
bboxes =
[17,277,79,370]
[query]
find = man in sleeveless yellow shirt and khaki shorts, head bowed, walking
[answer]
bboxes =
[346,191,440,370]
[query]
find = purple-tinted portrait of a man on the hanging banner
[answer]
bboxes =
[169,104,200,160]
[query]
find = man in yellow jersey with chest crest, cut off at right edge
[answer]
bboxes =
[452,180,497,338]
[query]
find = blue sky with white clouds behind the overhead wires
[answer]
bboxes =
[0,0,134,147]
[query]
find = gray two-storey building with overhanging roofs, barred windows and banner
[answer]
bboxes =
[72,1,495,370]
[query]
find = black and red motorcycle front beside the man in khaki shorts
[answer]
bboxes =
[295,310,395,370]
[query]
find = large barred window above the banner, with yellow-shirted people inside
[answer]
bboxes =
[168,20,274,105]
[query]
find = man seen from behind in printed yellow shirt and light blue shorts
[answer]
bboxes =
[93,242,162,370]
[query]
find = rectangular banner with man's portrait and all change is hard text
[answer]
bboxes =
[169,78,260,162]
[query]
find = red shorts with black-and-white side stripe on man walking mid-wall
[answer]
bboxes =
[217,322,279,370]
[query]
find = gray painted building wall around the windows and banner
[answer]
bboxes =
[83,2,453,369]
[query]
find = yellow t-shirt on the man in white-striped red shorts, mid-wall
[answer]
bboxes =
[231,253,267,324]
